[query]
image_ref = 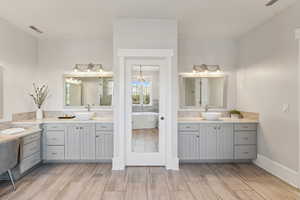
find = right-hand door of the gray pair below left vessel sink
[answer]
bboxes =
[80,125,96,160]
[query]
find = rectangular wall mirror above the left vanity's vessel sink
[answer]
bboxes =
[64,75,113,107]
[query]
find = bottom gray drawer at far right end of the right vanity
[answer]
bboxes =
[234,145,257,160]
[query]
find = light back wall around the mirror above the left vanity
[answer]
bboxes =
[38,39,113,110]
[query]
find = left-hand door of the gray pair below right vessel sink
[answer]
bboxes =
[203,124,217,160]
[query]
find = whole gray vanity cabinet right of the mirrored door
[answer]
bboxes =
[178,119,257,162]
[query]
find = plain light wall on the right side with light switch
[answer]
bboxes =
[237,2,300,170]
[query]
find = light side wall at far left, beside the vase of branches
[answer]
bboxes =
[0,19,37,120]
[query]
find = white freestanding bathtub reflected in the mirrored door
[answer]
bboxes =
[132,112,158,129]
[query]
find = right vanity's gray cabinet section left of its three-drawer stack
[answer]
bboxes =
[178,123,234,161]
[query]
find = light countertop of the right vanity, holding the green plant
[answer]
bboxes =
[178,117,259,123]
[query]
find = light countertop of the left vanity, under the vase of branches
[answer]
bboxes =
[12,118,113,125]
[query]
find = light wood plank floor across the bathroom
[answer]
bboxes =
[0,164,300,200]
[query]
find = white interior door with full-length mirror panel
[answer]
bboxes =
[126,59,167,166]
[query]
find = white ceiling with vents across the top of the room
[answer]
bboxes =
[0,0,297,39]
